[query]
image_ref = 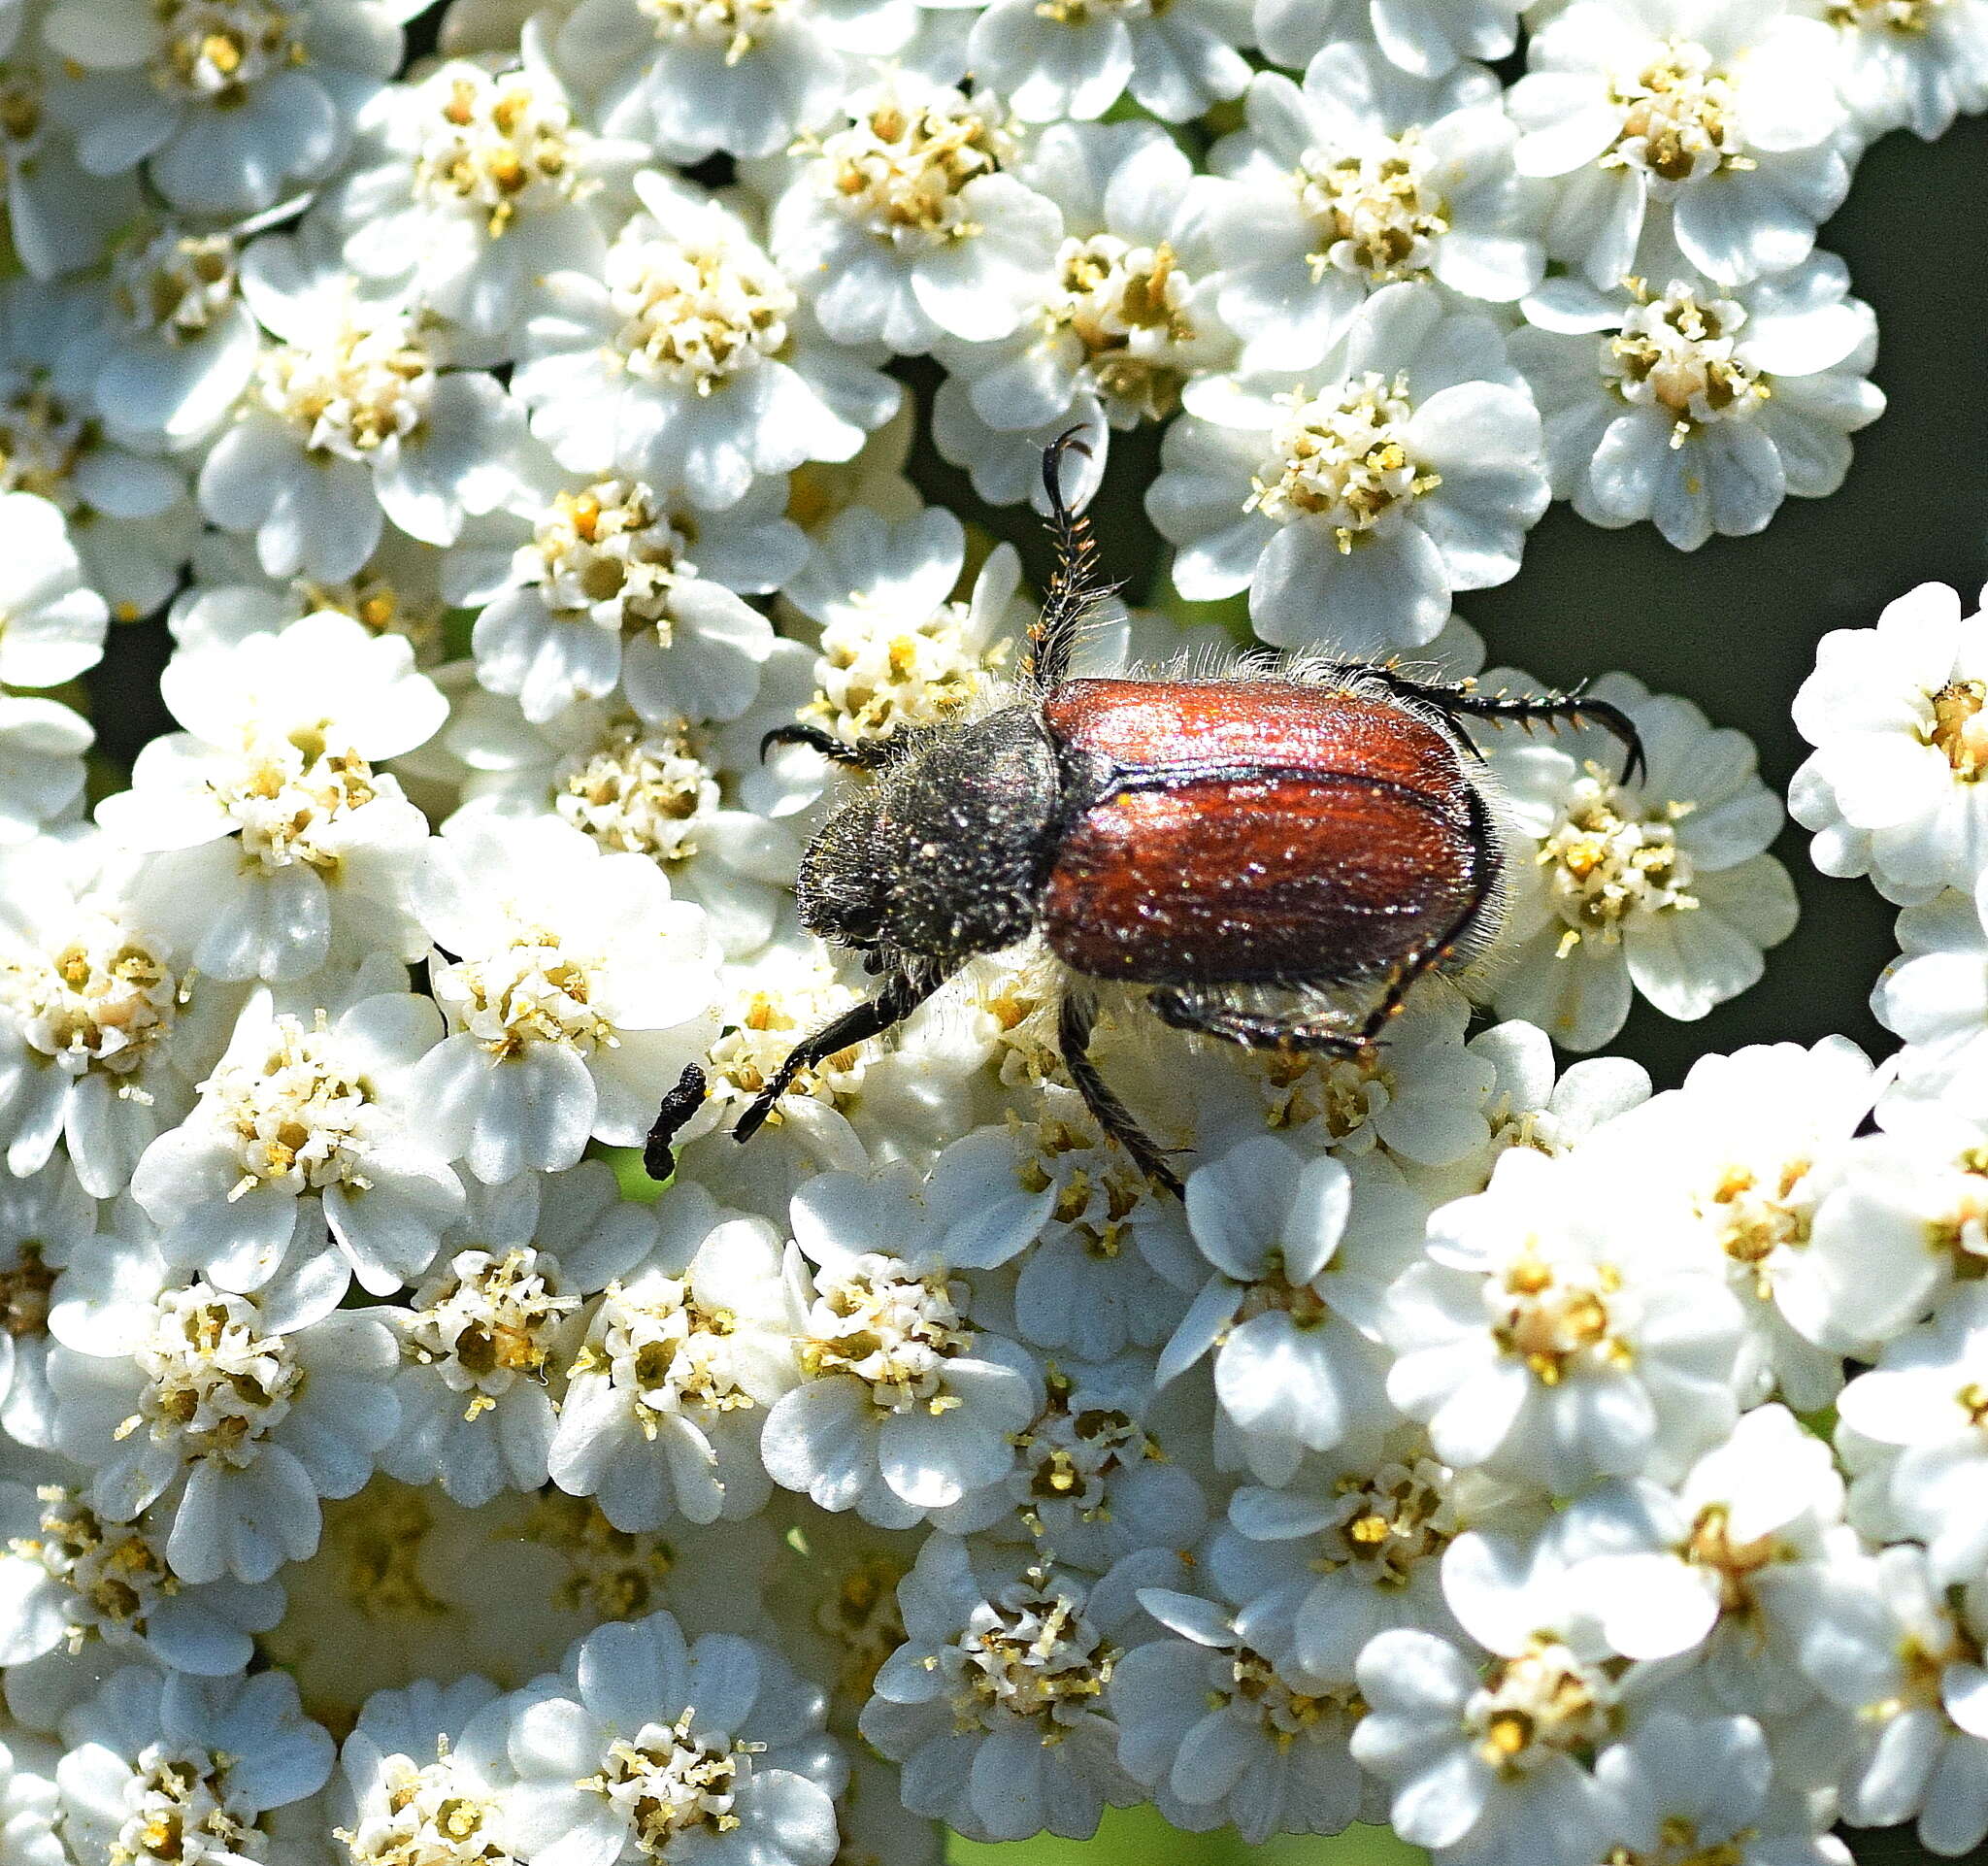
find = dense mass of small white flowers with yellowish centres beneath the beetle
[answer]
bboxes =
[0,0,1988,1866]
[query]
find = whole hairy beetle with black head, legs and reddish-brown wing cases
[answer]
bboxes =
[645,430,1644,1193]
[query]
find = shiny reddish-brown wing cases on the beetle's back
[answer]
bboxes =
[1040,681,1489,984]
